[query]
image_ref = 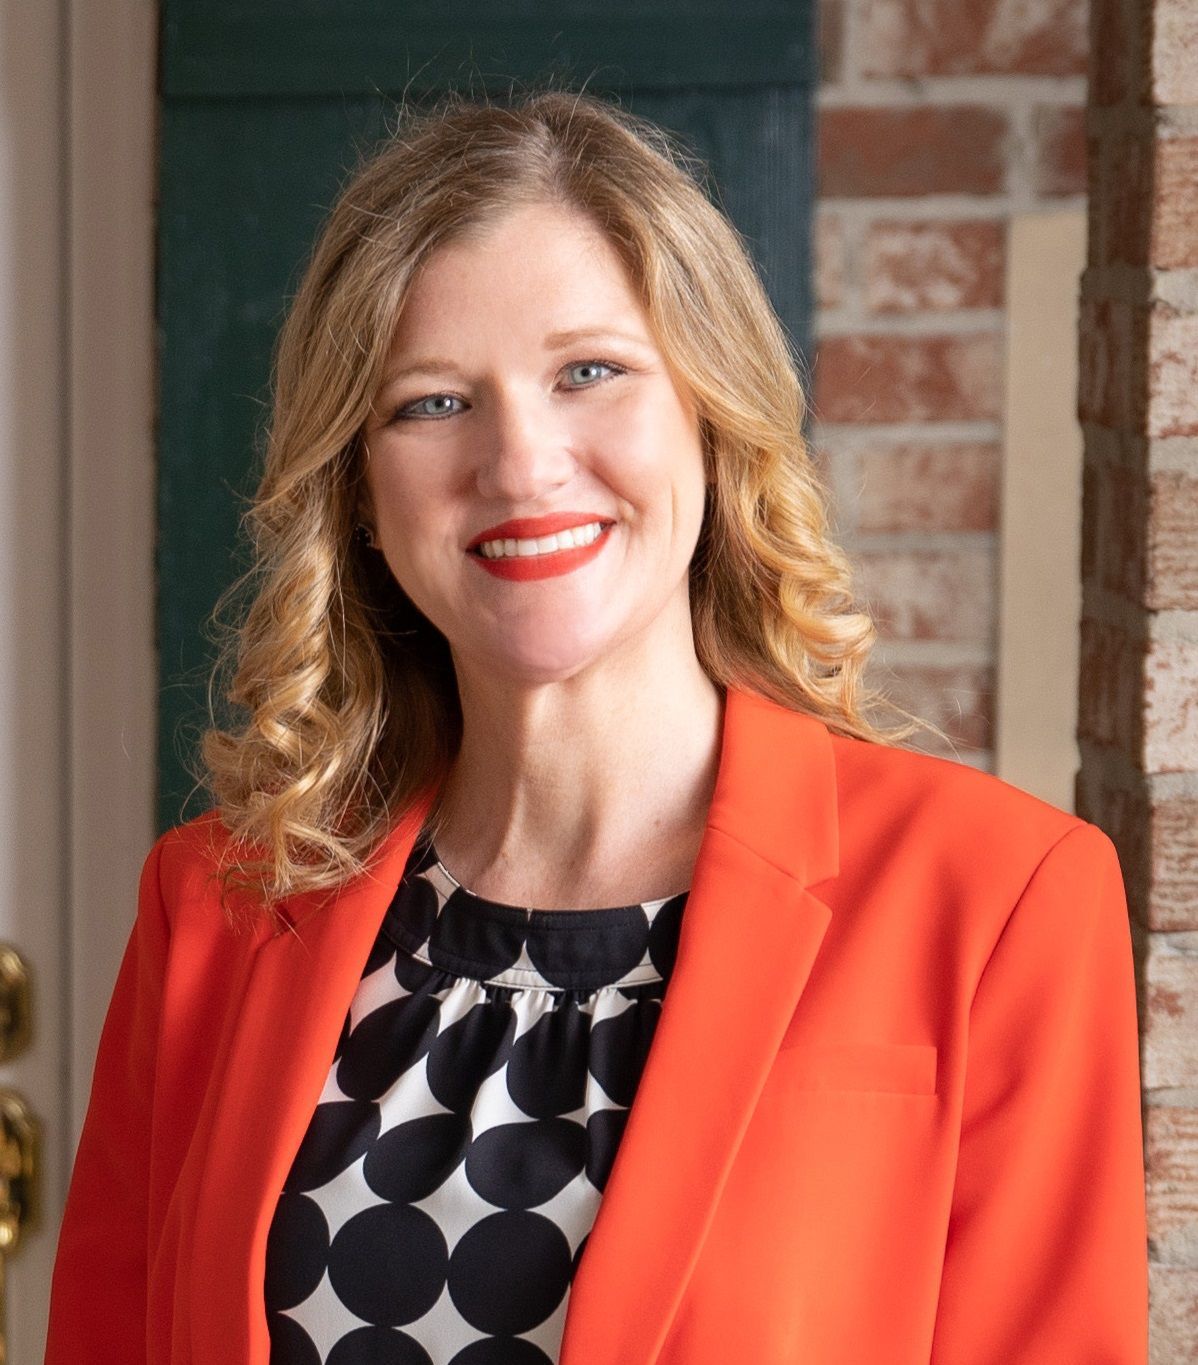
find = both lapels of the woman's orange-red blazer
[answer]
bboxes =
[183,687,839,1365]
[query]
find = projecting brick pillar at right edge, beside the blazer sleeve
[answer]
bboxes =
[1078,0,1198,1365]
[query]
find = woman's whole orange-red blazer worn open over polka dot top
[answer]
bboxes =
[46,689,1148,1365]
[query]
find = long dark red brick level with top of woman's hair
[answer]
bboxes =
[819,105,1007,199]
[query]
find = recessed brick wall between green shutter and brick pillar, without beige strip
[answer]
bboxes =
[813,0,1087,767]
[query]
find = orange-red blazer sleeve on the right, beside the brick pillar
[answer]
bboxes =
[931,823,1148,1365]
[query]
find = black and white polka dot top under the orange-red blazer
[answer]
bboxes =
[265,831,686,1365]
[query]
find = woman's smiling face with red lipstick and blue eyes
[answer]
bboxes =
[363,205,705,693]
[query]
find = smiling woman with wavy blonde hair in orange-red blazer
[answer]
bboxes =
[48,90,1148,1365]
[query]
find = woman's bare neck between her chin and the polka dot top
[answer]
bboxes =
[435,638,723,890]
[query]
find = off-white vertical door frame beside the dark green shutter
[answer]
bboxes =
[67,0,158,1130]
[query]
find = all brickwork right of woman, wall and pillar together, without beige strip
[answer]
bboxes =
[813,0,1198,1365]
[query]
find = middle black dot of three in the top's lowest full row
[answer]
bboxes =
[329,1204,449,1327]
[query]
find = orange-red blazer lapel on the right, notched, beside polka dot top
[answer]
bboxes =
[559,688,838,1365]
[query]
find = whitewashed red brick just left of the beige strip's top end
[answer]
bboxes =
[866,220,1006,313]
